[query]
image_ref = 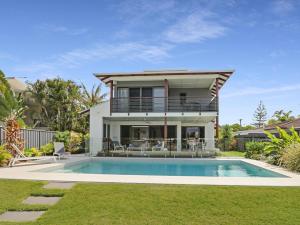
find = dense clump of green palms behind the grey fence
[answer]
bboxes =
[27,78,84,131]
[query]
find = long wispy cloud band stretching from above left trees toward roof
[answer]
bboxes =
[15,42,172,74]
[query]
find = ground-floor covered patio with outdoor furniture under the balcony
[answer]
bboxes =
[102,115,215,156]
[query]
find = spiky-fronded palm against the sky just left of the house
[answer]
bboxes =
[82,84,107,109]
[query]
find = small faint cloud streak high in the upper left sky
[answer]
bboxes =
[37,23,88,36]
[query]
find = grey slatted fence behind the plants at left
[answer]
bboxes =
[0,127,55,149]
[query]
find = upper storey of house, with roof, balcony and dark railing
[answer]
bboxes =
[95,70,234,115]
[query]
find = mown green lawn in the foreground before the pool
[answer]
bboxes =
[0,180,300,225]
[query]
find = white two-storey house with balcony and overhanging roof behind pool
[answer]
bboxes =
[90,70,234,155]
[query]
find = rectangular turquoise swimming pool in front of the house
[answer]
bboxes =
[46,159,286,178]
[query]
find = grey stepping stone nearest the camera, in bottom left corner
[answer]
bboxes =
[0,211,46,222]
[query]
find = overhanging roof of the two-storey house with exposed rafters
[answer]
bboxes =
[94,70,234,94]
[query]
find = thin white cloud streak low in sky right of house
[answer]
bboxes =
[222,84,300,98]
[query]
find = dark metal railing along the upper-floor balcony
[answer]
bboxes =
[111,97,218,113]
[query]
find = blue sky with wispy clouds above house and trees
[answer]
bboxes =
[0,0,300,125]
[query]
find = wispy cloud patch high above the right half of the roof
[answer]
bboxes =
[164,12,227,43]
